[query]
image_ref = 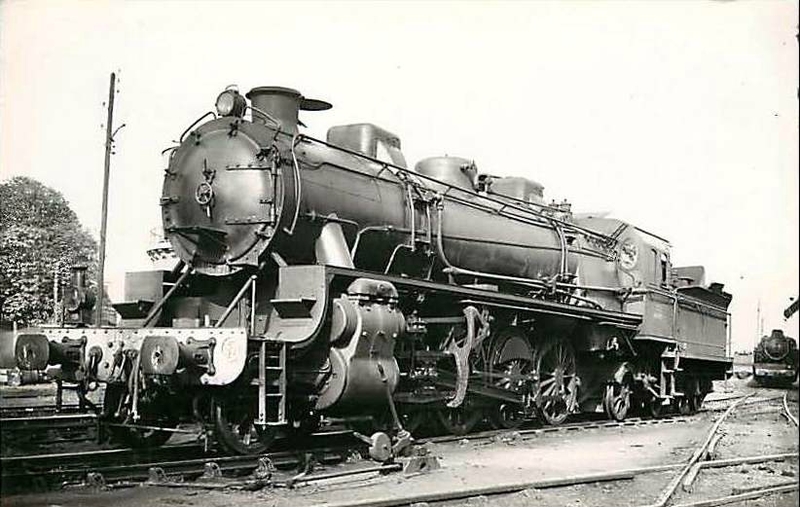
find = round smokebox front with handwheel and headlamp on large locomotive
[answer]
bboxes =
[161,90,283,275]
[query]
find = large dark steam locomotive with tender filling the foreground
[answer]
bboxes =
[16,87,732,454]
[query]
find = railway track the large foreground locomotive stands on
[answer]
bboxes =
[0,396,780,492]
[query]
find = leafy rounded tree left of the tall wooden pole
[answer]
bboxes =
[0,176,97,325]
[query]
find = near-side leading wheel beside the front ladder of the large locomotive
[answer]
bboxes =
[211,397,275,455]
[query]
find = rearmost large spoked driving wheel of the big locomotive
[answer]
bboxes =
[534,340,578,426]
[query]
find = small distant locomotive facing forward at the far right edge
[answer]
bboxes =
[753,329,798,385]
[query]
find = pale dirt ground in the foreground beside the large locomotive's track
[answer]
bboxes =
[2,378,798,507]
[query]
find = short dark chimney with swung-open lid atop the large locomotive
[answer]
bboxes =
[246,86,331,134]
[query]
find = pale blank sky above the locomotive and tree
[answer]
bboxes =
[0,0,800,350]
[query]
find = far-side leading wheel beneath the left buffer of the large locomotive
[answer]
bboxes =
[103,384,178,448]
